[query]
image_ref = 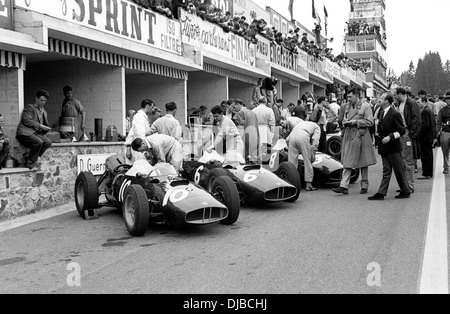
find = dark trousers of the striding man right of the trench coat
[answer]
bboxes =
[378,153,411,196]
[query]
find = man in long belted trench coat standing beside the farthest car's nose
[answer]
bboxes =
[333,88,377,194]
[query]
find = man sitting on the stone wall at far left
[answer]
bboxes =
[16,90,52,169]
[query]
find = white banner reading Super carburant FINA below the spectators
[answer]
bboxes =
[180,10,256,67]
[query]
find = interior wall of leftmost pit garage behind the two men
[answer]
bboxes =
[25,59,125,135]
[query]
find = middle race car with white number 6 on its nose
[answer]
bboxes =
[183,151,301,204]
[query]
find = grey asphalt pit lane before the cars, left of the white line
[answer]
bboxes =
[0,152,449,294]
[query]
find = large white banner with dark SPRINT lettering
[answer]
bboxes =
[14,0,182,55]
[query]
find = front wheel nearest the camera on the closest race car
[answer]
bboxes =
[123,185,150,237]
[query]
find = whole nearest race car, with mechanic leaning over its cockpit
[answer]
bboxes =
[75,156,240,237]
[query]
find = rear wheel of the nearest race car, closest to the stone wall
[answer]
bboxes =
[75,172,99,219]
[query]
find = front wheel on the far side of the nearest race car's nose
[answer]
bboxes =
[211,176,241,225]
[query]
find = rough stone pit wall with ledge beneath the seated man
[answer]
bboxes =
[0,143,124,221]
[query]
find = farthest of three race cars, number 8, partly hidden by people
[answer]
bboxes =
[263,140,360,186]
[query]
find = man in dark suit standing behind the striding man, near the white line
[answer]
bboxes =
[418,97,436,180]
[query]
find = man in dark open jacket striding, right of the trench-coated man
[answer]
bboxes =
[369,94,411,201]
